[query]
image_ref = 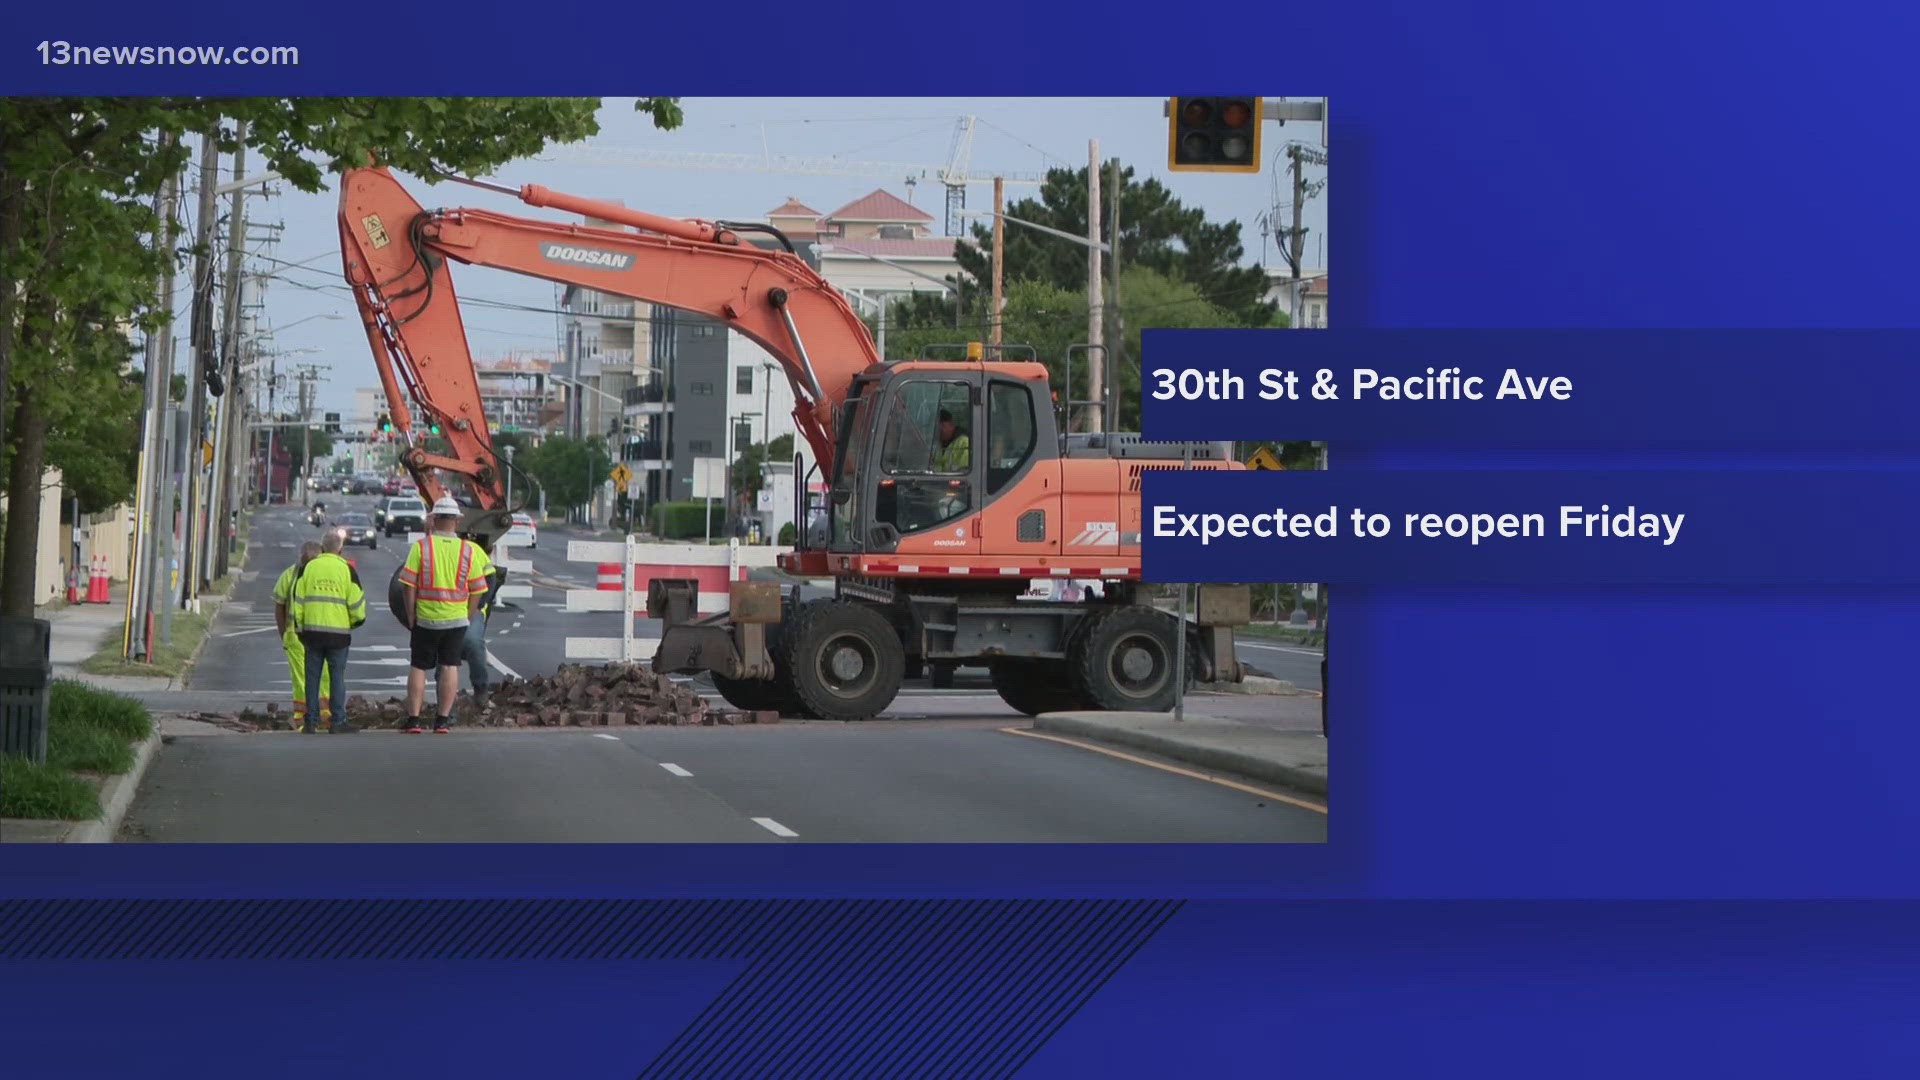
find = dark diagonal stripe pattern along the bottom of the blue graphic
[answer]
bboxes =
[0,899,1179,1080]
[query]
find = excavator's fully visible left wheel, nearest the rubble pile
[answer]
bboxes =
[781,600,906,721]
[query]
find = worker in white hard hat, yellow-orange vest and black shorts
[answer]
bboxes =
[399,496,493,734]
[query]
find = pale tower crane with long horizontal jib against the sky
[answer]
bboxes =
[541,115,1046,236]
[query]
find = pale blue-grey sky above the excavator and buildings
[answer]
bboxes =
[214,98,1334,411]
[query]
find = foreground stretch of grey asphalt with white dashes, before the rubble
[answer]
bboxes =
[123,721,1327,844]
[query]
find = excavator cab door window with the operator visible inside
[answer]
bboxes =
[874,380,973,532]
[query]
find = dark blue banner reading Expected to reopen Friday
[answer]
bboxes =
[1140,469,1920,588]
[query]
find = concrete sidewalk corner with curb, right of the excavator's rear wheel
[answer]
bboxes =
[1033,711,1327,798]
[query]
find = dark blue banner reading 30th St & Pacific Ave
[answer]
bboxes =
[1140,327,1920,452]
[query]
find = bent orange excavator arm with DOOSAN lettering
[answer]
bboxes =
[340,167,879,530]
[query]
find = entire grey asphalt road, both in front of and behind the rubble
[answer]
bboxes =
[125,496,1327,842]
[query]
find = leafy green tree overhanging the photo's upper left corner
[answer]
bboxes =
[0,96,680,615]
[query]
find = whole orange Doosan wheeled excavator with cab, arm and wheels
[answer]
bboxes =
[340,167,1250,721]
